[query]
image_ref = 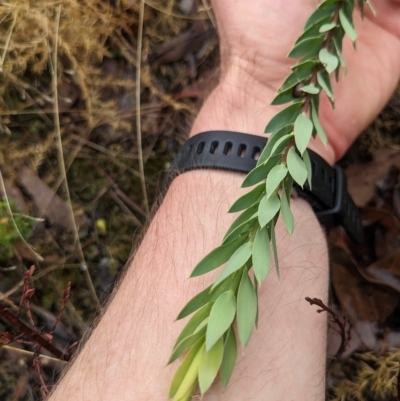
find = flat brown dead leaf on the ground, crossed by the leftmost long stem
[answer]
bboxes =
[18,167,83,230]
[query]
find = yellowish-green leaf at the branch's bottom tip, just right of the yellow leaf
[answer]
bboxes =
[199,338,224,394]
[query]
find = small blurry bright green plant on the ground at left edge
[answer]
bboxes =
[0,200,37,260]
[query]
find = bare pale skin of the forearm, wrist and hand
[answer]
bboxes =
[50,0,400,401]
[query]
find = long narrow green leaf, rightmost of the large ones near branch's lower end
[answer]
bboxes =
[237,269,257,347]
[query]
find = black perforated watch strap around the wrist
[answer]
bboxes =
[163,131,362,242]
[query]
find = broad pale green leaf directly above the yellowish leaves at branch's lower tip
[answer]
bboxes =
[206,291,236,350]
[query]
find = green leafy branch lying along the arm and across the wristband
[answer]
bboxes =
[169,0,370,401]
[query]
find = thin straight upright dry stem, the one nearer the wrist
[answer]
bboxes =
[136,0,149,213]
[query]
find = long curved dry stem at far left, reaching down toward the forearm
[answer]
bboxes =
[52,5,101,309]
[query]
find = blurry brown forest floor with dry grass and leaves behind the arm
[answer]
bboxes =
[0,0,400,401]
